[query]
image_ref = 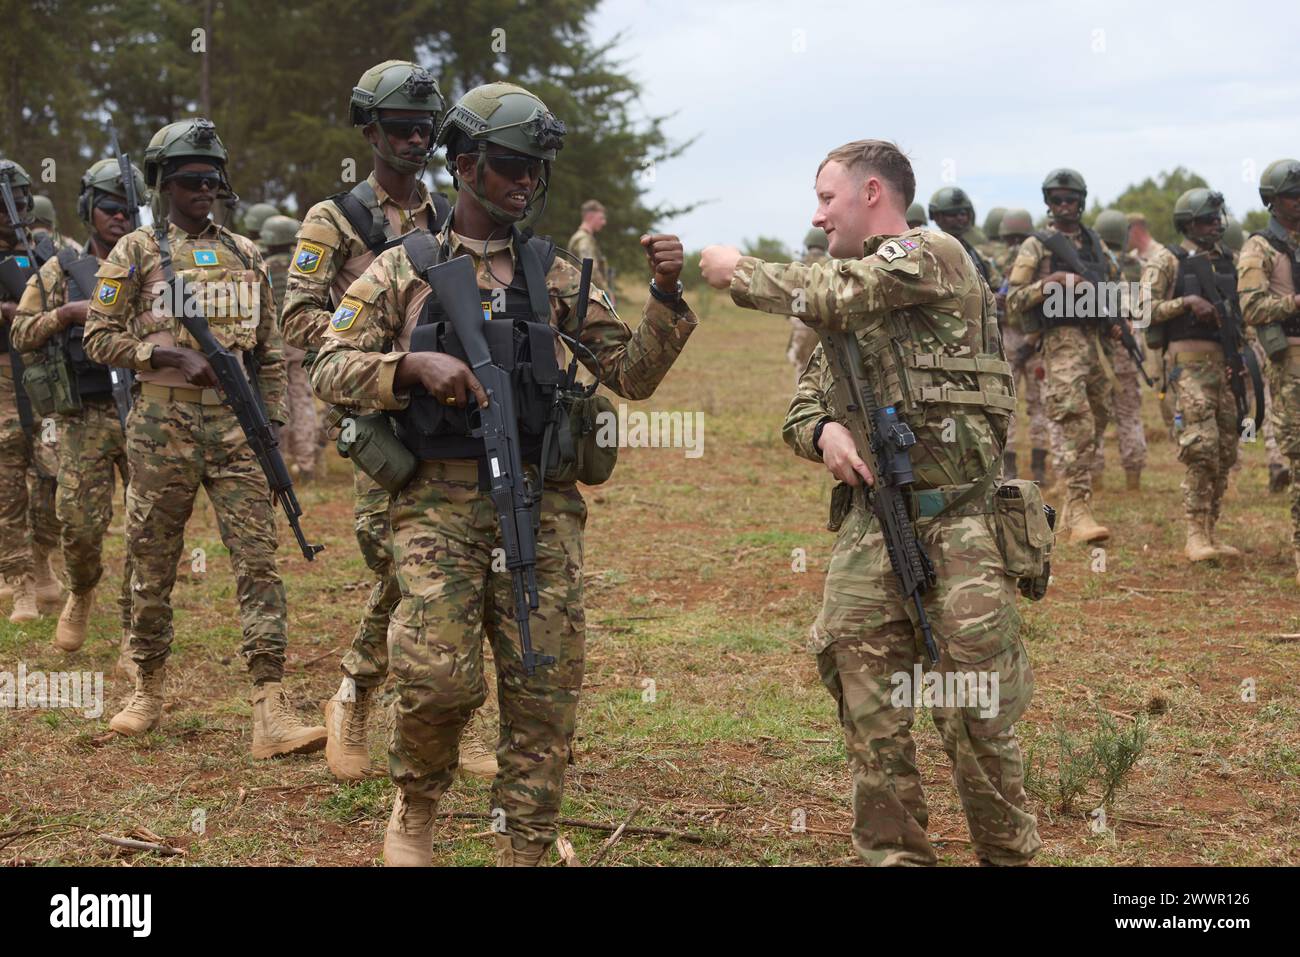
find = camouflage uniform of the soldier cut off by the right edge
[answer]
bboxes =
[1236,222,1300,553]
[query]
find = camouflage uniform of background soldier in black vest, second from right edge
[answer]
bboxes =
[1141,239,1239,528]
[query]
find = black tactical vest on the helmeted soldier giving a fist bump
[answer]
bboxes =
[394,230,562,464]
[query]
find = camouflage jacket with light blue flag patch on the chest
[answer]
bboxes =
[85,222,287,423]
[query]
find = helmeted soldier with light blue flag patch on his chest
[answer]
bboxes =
[85,117,325,758]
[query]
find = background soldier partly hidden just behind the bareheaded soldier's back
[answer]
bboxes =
[996,209,1049,485]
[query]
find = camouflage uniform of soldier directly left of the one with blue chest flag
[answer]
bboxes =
[13,247,131,629]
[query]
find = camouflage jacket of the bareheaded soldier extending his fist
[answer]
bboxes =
[731,228,1015,489]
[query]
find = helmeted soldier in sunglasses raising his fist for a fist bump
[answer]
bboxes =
[312,83,696,866]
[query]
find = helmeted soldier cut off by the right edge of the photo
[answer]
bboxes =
[1236,160,1300,585]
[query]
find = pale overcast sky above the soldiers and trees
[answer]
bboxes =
[593,0,1300,248]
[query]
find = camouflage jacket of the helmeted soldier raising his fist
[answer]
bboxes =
[311,226,697,411]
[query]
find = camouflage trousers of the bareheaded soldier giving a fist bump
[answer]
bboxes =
[811,506,1041,865]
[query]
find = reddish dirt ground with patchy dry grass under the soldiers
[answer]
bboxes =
[0,286,1300,866]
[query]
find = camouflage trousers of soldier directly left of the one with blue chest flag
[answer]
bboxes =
[55,398,131,628]
